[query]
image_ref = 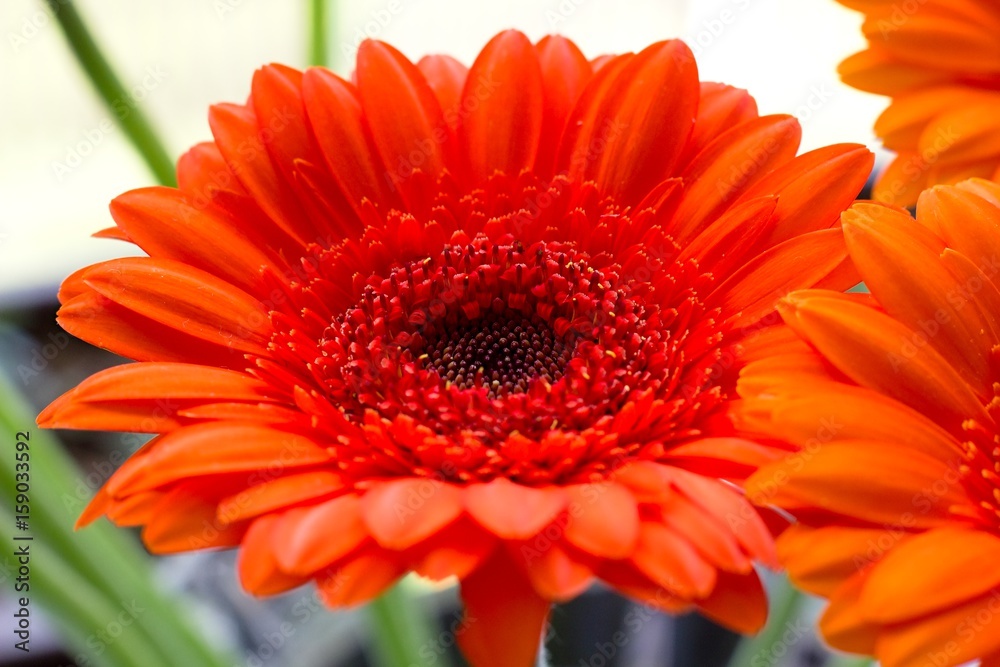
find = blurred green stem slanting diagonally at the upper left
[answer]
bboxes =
[46,0,177,185]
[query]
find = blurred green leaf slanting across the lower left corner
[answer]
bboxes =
[0,374,225,667]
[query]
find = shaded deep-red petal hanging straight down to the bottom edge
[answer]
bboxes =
[458,550,549,667]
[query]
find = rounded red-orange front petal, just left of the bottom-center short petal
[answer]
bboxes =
[362,477,463,550]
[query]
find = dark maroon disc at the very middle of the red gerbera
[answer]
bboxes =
[421,310,574,398]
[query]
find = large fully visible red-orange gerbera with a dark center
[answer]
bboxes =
[39,31,871,667]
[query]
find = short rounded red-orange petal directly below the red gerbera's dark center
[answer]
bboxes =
[463,477,569,540]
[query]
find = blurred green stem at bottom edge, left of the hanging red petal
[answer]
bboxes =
[368,580,448,667]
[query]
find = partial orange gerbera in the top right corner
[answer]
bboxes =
[838,0,1000,206]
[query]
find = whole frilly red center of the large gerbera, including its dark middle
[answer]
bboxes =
[255,174,724,484]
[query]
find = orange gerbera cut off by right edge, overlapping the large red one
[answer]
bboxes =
[740,180,1000,667]
